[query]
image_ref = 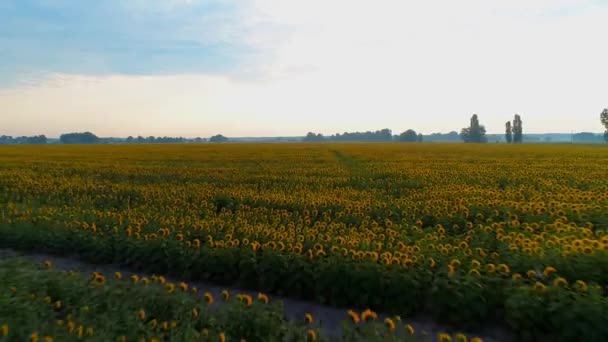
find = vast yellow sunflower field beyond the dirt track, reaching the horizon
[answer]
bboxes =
[0,144,608,341]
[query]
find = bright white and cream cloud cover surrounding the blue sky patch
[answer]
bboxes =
[0,0,608,136]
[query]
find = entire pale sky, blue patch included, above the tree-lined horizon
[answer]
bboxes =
[0,0,608,137]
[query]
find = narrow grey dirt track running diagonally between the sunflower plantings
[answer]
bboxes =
[0,248,514,342]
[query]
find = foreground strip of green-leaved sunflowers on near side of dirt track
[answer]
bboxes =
[0,257,483,342]
